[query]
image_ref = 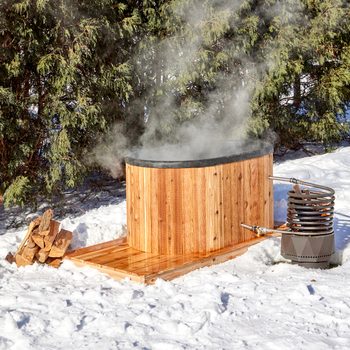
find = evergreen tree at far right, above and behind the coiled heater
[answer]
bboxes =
[254,0,350,148]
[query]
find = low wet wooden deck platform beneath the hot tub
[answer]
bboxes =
[65,237,265,284]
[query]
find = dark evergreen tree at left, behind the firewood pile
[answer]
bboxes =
[0,0,139,204]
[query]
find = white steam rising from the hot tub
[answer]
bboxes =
[92,0,288,177]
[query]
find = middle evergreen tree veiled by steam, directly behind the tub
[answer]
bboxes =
[132,0,270,144]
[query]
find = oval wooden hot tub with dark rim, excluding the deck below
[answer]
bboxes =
[126,142,273,255]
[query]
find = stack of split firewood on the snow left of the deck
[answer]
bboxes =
[10,209,73,267]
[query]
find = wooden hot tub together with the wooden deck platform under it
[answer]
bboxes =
[66,143,273,284]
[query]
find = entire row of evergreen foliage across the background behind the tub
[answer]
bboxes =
[0,0,350,204]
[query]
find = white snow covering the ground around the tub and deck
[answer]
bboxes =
[0,147,350,350]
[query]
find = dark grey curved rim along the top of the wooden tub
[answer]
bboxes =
[125,141,273,169]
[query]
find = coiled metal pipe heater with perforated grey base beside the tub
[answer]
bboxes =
[241,176,335,268]
